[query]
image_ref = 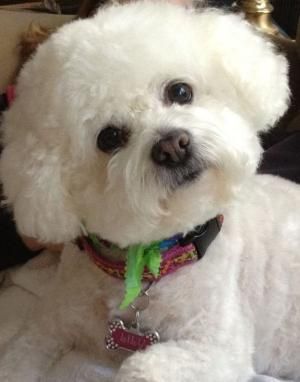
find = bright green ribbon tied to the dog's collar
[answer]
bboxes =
[120,242,161,309]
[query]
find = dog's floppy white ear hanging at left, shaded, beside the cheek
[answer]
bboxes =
[1,137,80,243]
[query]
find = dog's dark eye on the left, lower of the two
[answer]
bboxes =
[97,125,129,153]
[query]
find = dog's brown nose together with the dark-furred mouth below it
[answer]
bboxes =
[151,129,203,188]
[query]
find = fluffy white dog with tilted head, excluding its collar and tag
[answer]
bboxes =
[0,1,300,382]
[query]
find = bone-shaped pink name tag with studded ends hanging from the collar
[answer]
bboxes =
[105,319,159,352]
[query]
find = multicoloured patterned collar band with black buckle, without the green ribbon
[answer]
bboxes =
[78,215,223,281]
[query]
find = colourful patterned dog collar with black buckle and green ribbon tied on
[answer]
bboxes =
[78,215,223,308]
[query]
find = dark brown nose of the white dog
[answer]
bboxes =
[151,129,191,167]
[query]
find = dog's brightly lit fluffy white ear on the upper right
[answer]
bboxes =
[202,11,290,131]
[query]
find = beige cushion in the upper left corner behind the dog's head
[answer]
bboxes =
[0,10,74,93]
